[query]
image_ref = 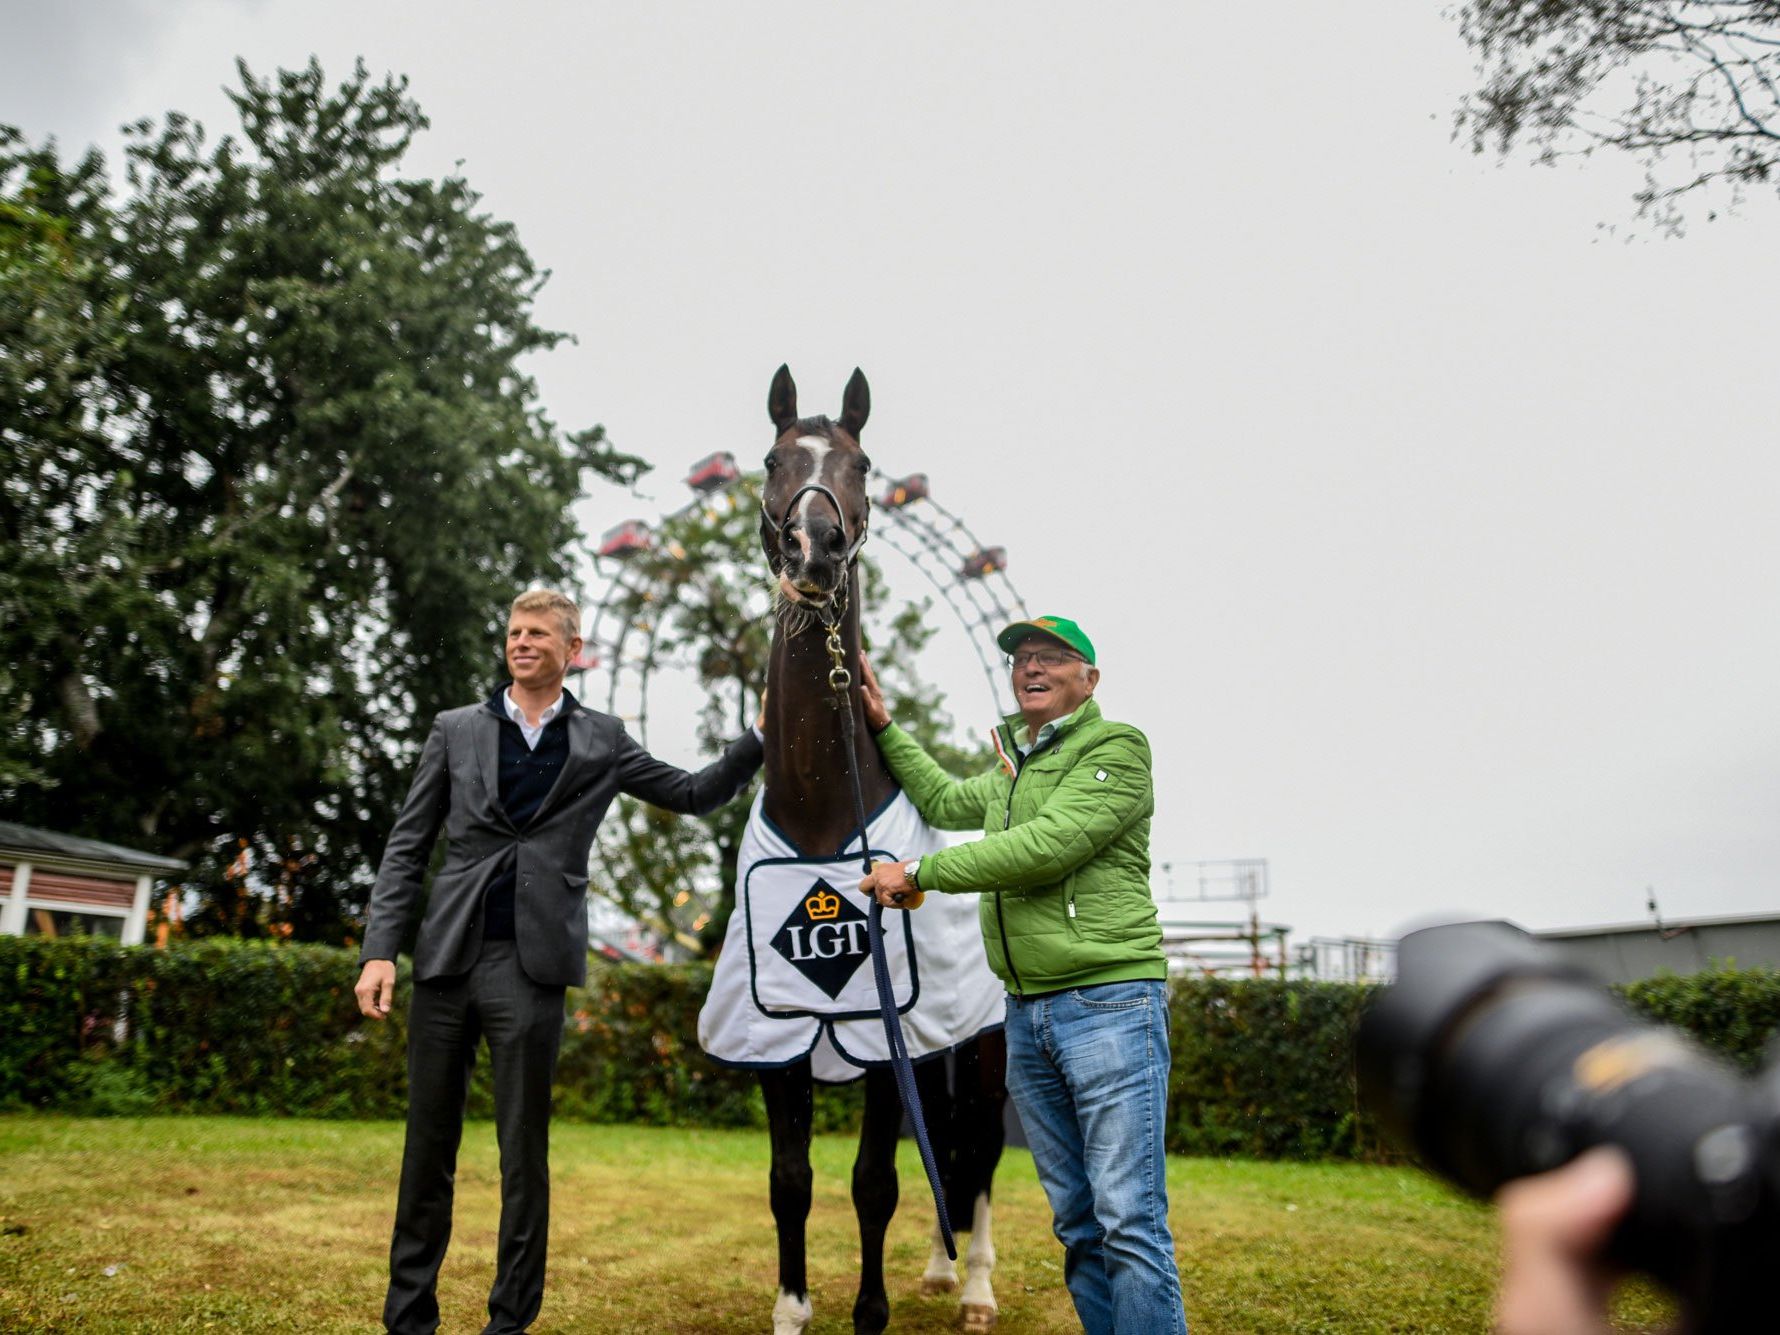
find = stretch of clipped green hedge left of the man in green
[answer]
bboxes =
[0,936,860,1130]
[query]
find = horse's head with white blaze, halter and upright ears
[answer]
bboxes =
[760,367,872,607]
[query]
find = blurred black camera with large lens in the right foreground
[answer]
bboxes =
[1358,922,1780,1333]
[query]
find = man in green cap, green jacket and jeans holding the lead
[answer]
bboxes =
[860,616,1185,1335]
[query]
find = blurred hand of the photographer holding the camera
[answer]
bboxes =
[1495,1145,1634,1335]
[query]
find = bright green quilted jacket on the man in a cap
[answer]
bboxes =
[878,700,1168,997]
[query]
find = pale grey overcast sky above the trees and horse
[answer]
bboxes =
[0,0,1780,942]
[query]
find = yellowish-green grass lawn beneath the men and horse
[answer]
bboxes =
[0,1114,1664,1335]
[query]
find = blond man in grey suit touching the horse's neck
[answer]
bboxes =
[354,589,760,1335]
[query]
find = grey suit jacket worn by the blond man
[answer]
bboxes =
[360,703,760,986]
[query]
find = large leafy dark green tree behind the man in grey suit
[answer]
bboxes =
[0,62,641,940]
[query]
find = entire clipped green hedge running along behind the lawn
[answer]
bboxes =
[10,936,1780,1159]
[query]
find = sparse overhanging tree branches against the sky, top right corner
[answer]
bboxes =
[1458,0,1780,230]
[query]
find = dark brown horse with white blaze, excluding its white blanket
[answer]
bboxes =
[758,367,1006,1335]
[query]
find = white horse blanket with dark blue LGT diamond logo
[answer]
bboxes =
[698,790,1006,1084]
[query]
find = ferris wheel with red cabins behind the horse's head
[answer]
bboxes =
[570,452,1027,746]
